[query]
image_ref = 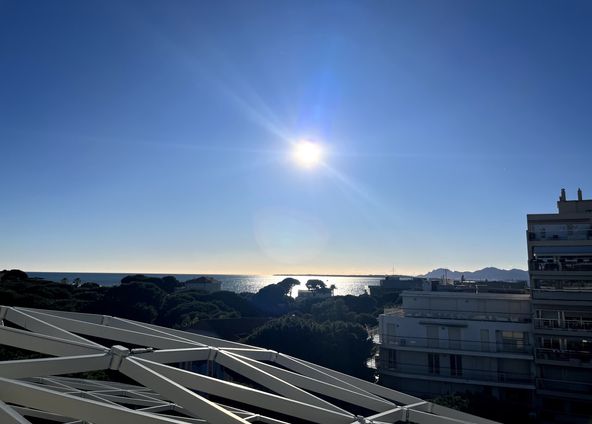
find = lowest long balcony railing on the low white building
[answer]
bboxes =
[377,357,534,384]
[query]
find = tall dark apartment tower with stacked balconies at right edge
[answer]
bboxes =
[527,190,592,423]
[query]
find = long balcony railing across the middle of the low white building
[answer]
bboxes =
[379,334,532,354]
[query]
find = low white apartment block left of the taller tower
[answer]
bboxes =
[377,286,535,408]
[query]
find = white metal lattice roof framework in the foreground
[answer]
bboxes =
[0,306,500,424]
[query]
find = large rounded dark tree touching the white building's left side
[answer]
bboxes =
[244,316,373,379]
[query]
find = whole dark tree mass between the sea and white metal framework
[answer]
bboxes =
[0,273,377,378]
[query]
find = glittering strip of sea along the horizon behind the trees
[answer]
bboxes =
[27,272,383,297]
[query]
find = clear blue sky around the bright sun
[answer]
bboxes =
[0,0,592,273]
